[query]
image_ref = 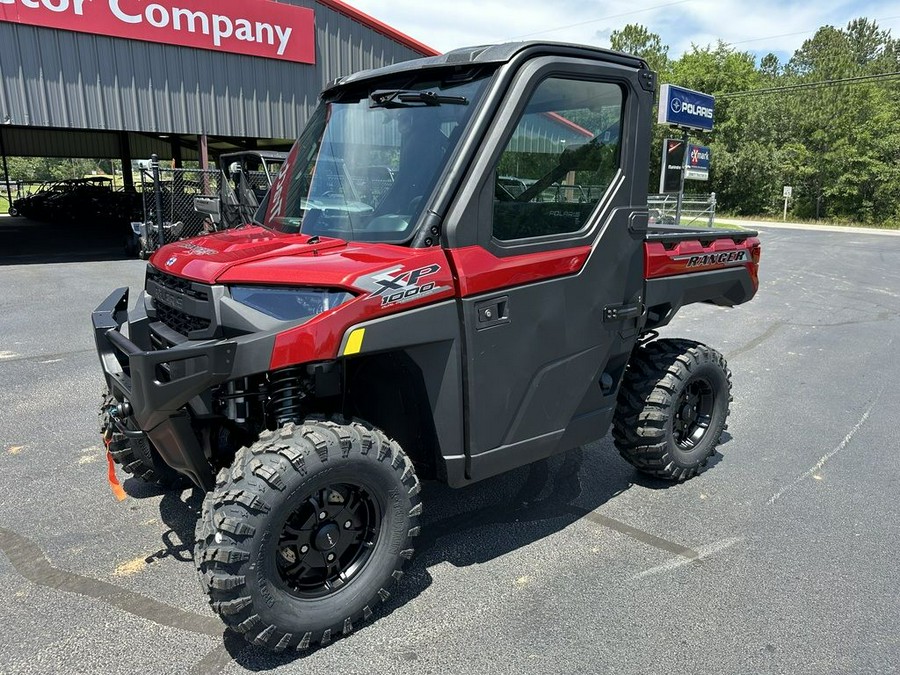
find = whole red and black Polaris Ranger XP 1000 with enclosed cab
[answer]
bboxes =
[93,43,759,650]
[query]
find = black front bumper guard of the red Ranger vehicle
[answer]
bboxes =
[91,288,238,490]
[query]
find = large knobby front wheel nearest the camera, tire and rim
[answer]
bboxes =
[194,419,422,651]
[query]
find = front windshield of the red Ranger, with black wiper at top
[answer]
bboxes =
[263,73,487,243]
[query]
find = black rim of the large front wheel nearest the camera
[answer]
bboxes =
[275,483,382,598]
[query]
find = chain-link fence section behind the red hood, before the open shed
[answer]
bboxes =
[141,164,224,253]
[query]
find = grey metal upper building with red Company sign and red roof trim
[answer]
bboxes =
[0,0,435,235]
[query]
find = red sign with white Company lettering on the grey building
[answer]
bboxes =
[0,0,316,63]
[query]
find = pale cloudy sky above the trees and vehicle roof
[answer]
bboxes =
[346,0,900,61]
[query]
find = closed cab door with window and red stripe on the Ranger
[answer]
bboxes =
[446,57,652,480]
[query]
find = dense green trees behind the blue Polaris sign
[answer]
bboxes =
[628,18,900,227]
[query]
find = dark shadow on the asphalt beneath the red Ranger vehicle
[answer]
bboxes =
[142,448,684,671]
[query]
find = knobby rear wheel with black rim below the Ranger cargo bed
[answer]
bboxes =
[613,340,731,481]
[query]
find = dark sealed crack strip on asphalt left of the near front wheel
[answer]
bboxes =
[0,527,224,638]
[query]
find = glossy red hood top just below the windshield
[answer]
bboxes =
[150,226,347,284]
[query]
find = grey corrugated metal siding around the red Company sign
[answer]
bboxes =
[0,0,421,145]
